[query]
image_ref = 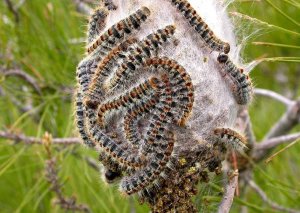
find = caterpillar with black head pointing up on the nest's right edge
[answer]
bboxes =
[218,54,253,105]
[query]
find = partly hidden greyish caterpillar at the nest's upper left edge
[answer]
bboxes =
[87,7,108,44]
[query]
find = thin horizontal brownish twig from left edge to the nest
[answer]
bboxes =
[0,131,81,145]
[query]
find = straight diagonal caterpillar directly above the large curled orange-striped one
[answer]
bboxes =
[106,25,175,90]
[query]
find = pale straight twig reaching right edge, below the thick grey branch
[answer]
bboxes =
[255,132,300,152]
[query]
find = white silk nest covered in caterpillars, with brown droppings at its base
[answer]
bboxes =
[75,0,252,212]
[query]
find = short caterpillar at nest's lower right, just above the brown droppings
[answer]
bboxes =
[214,128,247,152]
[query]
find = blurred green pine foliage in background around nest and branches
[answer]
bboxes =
[0,0,300,212]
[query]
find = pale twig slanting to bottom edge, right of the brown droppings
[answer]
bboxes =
[218,170,238,213]
